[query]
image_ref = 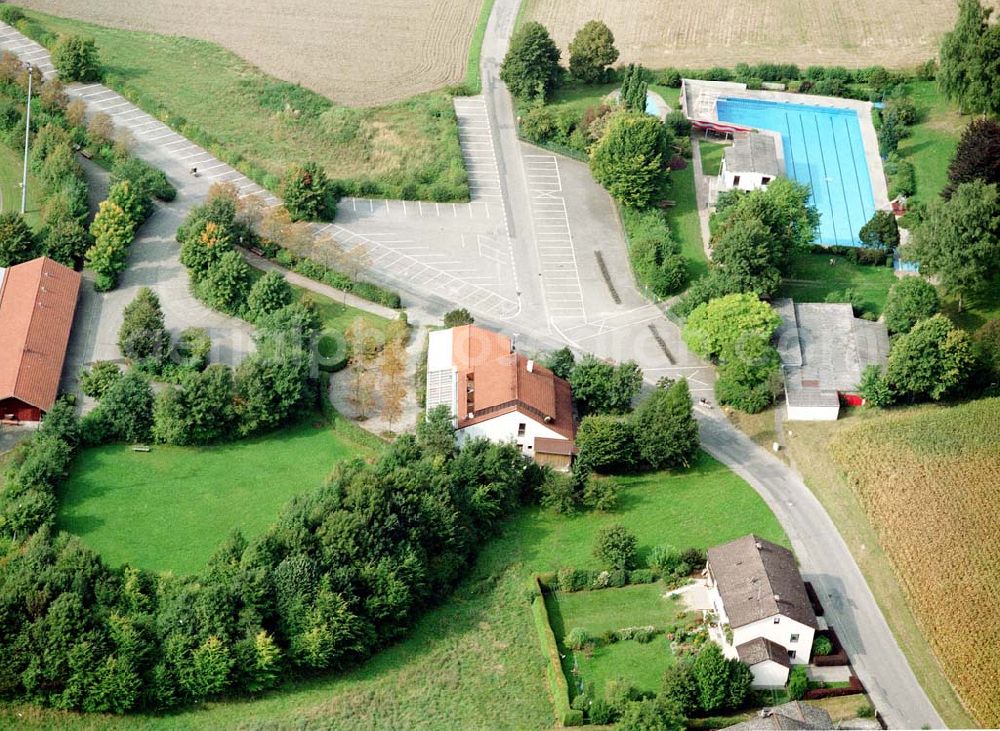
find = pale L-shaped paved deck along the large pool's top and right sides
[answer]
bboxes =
[681,79,892,216]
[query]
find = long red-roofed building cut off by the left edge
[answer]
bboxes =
[0,257,80,422]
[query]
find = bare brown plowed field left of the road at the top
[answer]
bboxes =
[17,0,482,105]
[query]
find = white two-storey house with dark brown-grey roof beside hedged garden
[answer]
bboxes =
[706,534,819,688]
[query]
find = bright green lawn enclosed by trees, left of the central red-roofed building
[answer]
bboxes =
[58,415,369,574]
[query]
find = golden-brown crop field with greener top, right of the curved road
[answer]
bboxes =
[830,398,1000,728]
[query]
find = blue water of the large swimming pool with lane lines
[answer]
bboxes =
[716,98,875,246]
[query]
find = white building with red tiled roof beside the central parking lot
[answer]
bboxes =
[427,325,576,469]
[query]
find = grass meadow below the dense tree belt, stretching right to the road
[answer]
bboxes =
[9,455,788,731]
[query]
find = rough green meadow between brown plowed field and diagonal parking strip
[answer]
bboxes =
[11,11,469,200]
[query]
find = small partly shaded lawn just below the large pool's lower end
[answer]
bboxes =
[777,254,896,315]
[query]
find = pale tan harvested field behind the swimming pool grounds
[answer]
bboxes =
[524,0,995,68]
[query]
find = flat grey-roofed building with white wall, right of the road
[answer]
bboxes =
[774,299,889,421]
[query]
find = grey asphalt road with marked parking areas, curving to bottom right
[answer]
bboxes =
[0,11,944,728]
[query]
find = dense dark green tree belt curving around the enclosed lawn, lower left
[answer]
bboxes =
[0,404,542,713]
